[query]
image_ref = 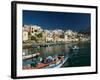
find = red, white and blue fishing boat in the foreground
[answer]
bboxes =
[23,56,68,69]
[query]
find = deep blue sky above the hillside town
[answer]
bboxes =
[23,10,91,31]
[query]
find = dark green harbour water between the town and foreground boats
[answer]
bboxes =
[23,42,91,67]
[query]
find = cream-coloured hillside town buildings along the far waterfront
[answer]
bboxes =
[22,25,90,43]
